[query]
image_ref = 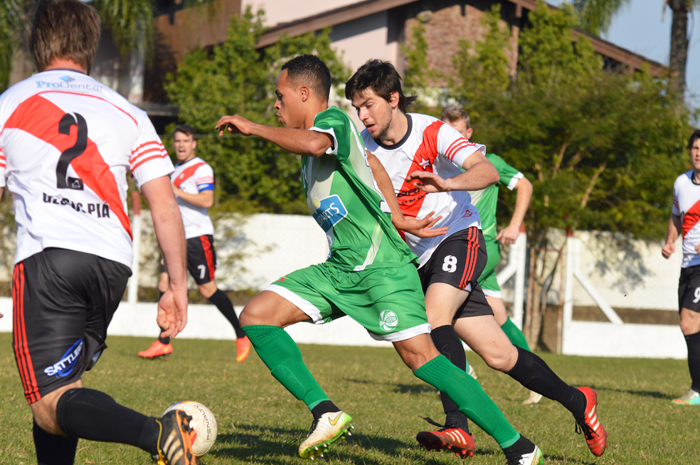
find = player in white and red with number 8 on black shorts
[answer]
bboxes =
[345,60,607,456]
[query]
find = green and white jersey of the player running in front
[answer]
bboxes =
[301,107,417,271]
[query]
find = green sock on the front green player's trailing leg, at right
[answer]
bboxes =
[414,355,520,449]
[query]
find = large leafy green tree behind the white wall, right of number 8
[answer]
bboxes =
[453,2,689,344]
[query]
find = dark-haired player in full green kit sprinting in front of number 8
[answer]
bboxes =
[216,55,542,465]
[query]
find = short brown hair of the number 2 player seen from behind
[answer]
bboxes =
[29,0,101,71]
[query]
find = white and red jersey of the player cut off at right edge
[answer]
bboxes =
[672,170,700,268]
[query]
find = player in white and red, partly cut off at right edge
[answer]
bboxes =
[661,129,700,405]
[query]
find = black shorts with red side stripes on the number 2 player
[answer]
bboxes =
[12,248,131,404]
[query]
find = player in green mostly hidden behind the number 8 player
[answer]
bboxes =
[440,107,542,405]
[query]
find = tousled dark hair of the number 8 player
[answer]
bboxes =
[345,60,417,111]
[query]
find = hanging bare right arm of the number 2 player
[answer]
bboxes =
[141,176,187,337]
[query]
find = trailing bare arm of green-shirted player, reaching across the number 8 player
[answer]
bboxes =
[367,152,449,237]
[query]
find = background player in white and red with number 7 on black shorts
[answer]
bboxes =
[138,124,250,363]
